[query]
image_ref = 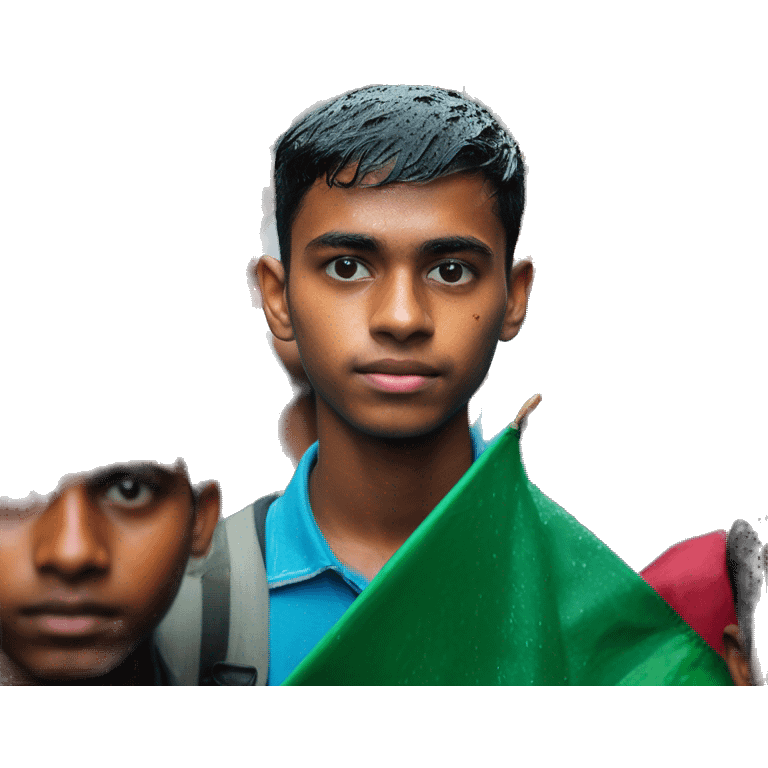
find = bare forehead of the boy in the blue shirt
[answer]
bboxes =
[292,168,505,253]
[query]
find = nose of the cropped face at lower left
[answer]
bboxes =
[34,483,108,575]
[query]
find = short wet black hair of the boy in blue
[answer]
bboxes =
[273,85,527,292]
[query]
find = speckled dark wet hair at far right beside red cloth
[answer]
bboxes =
[725,520,768,658]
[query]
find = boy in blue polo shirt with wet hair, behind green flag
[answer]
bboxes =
[250,86,760,685]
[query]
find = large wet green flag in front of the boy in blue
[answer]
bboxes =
[283,425,733,685]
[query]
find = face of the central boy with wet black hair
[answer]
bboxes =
[260,168,530,438]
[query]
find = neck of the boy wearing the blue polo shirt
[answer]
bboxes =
[309,398,473,564]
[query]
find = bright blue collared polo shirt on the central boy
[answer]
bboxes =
[265,413,501,685]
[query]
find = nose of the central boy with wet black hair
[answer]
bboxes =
[369,267,435,341]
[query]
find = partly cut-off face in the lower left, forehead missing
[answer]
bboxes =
[0,461,221,685]
